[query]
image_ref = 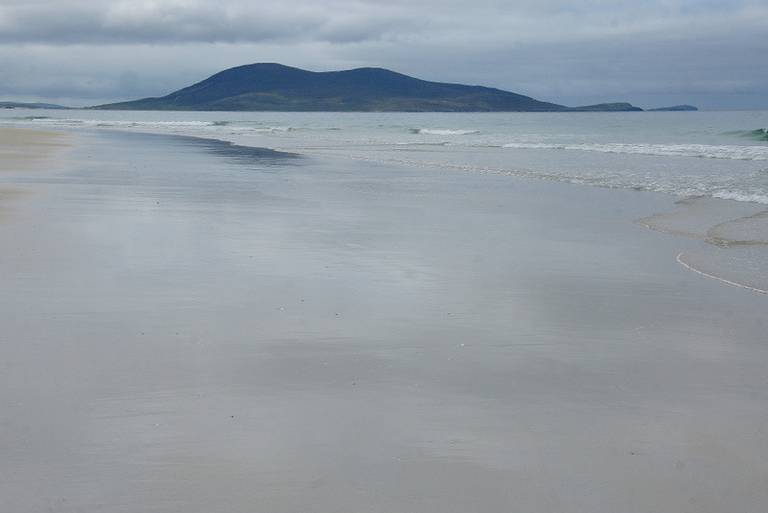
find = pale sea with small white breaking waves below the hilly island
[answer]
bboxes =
[0,109,768,204]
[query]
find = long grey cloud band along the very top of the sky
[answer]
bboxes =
[0,0,768,44]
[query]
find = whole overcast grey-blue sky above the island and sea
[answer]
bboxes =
[0,0,768,109]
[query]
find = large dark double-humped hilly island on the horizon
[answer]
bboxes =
[91,63,643,112]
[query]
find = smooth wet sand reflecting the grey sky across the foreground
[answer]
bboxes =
[0,132,768,513]
